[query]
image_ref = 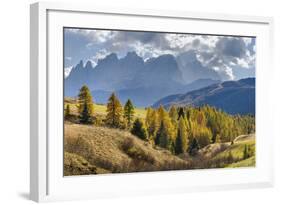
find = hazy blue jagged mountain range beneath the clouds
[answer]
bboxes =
[64,52,220,107]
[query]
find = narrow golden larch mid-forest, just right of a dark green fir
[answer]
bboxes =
[175,117,188,154]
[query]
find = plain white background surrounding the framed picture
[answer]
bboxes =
[0,0,281,205]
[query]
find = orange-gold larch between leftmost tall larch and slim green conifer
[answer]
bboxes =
[106,93,123,128]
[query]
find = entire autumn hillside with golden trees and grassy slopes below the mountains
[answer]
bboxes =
[64,86,255,175]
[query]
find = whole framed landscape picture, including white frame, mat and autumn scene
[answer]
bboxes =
[30,3,273,201]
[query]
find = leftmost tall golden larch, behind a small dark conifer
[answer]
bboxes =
[78,85,94,116]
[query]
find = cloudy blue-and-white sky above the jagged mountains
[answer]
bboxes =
[64,28,256,80]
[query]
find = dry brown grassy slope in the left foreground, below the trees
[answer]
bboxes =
[64,123,188,175]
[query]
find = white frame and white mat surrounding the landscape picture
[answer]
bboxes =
[30,2,274,202]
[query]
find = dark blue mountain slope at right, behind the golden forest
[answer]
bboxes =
[153,78,255,114]
